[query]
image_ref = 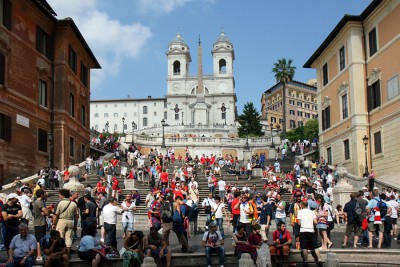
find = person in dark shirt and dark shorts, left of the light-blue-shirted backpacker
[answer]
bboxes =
[342,193,365,248]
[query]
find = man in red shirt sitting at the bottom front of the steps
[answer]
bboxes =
[269,221,292,264]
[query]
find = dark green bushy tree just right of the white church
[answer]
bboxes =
[238,102,264,137]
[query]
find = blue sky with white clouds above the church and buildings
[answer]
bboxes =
[47,0,371,114]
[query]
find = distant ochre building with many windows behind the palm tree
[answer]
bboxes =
[261,80,318,133]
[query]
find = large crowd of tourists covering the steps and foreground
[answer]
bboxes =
[0,140,399,266]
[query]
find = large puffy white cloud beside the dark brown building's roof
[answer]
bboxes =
[48,0,152,89]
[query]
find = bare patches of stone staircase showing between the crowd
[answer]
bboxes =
[47,155,293,231]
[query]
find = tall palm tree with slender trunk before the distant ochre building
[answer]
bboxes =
[272,58,296,139]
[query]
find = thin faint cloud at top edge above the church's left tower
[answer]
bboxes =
[138,0,192,13]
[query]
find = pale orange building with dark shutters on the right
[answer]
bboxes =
[304,0,400,179]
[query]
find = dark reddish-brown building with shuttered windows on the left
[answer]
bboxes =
[0,0,100,182]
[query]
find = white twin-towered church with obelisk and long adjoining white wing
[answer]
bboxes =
[90,31,236,135]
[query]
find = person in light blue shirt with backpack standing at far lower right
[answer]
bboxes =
[366,187,387,248]
